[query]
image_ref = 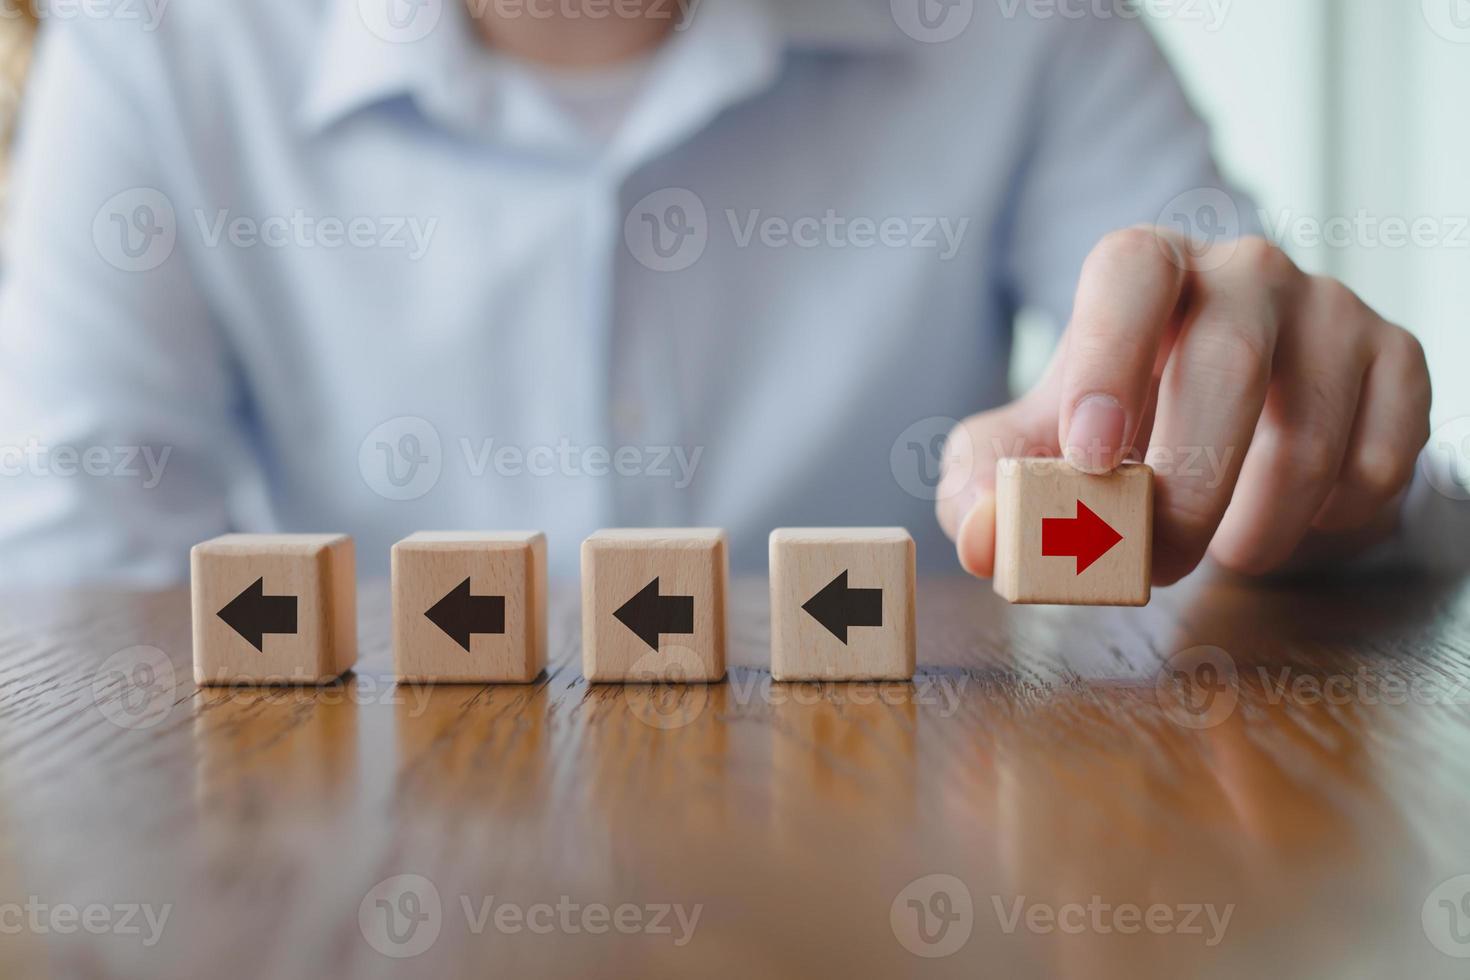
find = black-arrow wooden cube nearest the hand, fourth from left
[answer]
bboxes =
[770,527,914,680]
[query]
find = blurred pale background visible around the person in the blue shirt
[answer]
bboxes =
[0,0,1470,487]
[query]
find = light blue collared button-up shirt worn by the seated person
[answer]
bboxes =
[0,0,1446,585]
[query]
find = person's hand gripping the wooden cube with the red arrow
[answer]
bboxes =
[938,228,1430,585]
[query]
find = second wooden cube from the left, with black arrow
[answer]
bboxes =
[392,532,547,683]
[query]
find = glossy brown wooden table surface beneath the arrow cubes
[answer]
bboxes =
[0,579,1470,980]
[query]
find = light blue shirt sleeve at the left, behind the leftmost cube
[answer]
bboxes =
[0,18,250,588]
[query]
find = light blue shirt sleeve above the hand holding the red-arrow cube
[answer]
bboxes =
[1001,18,1260,331]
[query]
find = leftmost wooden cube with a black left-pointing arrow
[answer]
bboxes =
[190,535,357,685]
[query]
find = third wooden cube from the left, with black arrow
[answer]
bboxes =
[582,529,729,682]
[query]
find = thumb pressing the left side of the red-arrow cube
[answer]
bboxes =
[936,392,1060,579]
